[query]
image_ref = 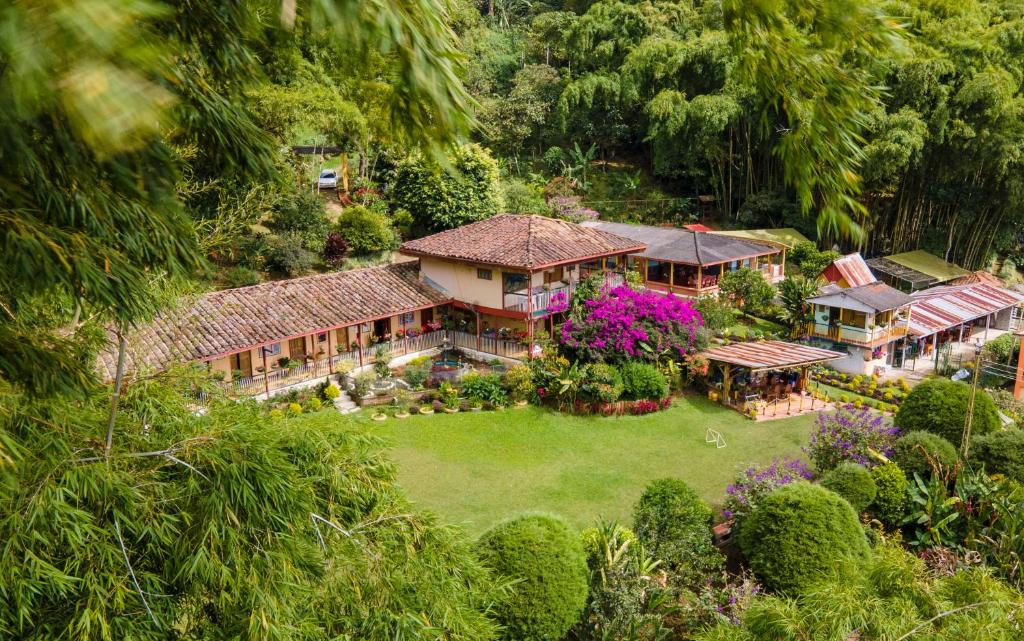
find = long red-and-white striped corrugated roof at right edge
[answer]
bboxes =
[908,283,1024,336]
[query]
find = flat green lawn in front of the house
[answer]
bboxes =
[356,397,813,535]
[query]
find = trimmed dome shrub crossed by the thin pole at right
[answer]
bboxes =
[896,379,999,443]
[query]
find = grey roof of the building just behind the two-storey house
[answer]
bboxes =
[584,221,781,265]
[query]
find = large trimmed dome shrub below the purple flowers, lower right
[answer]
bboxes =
[738,482,869,594]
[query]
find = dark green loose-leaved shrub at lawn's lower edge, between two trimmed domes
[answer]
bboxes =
[633,478,723,584]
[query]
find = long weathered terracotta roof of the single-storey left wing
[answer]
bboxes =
[98,262,449,379]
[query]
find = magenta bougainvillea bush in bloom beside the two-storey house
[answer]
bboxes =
[561,286,702,362]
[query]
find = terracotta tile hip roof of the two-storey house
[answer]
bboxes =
[398,214,644,269]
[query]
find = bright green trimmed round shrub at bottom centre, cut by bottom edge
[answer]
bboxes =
[477,515,588,641]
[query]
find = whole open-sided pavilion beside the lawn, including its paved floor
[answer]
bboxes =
[701,341,846,420]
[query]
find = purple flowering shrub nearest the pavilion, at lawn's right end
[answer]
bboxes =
[804,405,899,473]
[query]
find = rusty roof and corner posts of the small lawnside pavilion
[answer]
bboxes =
[701,341,846,411]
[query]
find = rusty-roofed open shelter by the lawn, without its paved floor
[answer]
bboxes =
[701,341,846,410]
